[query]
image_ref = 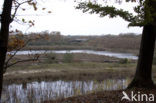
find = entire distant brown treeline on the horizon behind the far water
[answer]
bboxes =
[9,32,141,50]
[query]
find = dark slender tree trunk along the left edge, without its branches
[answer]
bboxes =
[0,0,12,101]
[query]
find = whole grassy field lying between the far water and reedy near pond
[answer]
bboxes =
[4,54,136,83]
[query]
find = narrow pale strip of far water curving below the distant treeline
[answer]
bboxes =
[9,50,138,60]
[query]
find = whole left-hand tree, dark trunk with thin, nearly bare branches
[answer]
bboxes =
[0,0,37,101]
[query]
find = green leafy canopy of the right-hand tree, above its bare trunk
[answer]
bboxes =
[76,0,156,26]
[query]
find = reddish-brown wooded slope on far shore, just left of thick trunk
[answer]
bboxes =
[88,34,141,50]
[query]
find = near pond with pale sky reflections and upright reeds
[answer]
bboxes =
[2,79,129,103]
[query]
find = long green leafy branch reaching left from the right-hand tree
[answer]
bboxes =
[76,2,144,26]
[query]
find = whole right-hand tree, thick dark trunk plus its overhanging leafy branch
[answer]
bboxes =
[76,0,156,88]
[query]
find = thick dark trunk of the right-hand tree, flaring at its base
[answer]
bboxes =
[128,24,156,88]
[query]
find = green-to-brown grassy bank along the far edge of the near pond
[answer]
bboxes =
[4,62,136,83]
